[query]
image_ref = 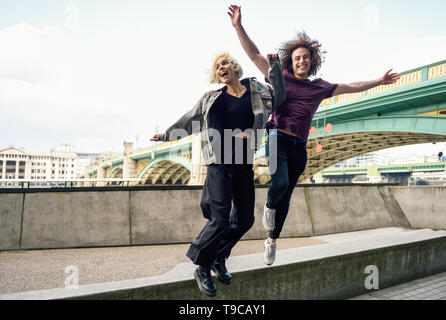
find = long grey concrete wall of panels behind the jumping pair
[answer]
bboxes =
[0,185,446,250]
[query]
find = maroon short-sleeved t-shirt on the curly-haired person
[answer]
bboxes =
[272,70,338,142]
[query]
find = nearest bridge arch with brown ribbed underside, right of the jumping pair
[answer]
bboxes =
[256,116,446,183]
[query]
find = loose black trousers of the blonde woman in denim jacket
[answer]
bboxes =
[186,164,255,267]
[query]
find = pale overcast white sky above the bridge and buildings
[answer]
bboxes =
[0,0,446,159]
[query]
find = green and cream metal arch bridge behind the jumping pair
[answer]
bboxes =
[86,60,446,184]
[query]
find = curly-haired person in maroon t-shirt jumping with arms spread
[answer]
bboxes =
[228,5,399,265]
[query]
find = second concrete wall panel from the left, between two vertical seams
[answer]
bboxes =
[20,191,130,249]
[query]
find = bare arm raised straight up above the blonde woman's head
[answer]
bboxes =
[228,5,269,78]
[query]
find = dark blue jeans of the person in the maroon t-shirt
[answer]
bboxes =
[266,134,307,239]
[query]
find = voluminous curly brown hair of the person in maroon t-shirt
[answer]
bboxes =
[278,31,322,76]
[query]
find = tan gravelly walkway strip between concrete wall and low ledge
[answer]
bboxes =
[0,238,326,295]
